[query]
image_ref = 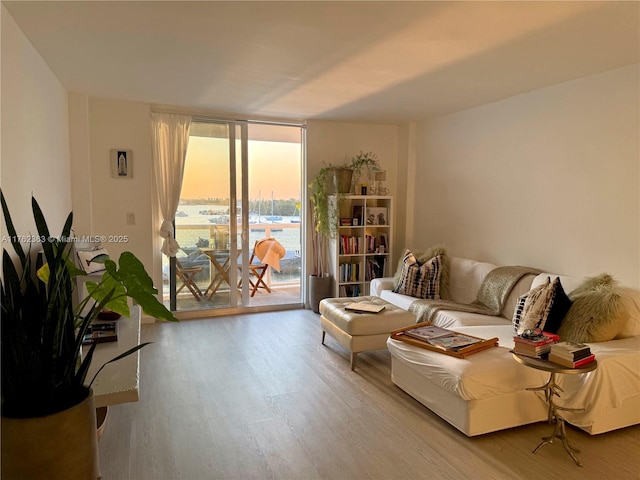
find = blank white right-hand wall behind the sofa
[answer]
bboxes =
[407,65,640,287]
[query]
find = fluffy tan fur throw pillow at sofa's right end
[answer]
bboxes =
[558,274,626,343]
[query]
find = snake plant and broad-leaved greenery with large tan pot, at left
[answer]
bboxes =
[0,192,177,479]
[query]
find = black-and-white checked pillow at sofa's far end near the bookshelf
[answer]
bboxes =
[393,250,443,300]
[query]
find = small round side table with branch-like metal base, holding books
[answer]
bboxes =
[513,353,598,467]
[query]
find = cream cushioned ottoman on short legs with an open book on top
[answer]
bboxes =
[320,297,416,370]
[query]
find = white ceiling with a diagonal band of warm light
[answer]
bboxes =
[2,1,640,123]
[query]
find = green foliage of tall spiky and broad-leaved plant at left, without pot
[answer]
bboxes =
[0,192,177,418]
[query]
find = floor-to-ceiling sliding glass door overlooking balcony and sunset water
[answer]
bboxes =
[163,119,304,315]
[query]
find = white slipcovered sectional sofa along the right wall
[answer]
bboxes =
[370,257,640,436]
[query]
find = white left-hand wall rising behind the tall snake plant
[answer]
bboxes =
[0,6,71,248]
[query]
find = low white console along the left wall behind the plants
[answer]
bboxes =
[83,305,142,408]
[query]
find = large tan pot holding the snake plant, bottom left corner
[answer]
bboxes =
[1,389,99,480]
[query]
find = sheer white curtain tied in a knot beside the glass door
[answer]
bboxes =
[151,113,191,257]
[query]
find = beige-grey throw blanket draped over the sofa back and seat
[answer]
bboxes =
[409,266,540,323]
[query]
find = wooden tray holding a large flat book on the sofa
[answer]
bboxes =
[391,322,498,358]
